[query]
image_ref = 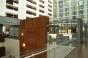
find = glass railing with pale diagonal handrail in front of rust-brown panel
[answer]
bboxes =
[21,35,77,58]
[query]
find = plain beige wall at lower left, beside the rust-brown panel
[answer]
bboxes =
[5,39,20,58]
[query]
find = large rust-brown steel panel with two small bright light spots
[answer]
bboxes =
[20,16,49,58]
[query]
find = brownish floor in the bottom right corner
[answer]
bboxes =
[66,41,88,58]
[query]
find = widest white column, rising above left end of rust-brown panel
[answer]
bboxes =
[18,0,26,20]
